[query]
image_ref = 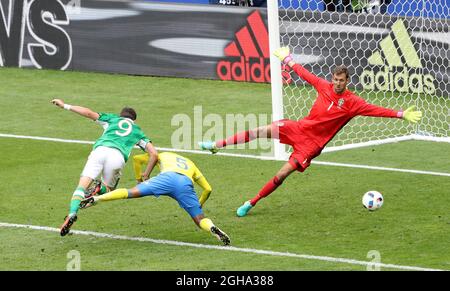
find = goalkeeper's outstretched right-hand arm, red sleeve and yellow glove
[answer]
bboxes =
[355,98,422,123]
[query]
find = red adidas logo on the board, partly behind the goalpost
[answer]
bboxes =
[216,10,292,83]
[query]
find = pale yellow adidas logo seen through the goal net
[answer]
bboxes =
[360,19,436,94]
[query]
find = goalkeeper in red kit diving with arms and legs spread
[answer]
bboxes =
[199,47,422,216]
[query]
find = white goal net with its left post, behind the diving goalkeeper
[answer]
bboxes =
[268,0,450,159]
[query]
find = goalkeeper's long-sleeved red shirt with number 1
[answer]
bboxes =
[292,64,402,148]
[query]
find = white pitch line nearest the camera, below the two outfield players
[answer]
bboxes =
[0,222,443,271]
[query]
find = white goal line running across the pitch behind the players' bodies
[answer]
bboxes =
[0,133,450,177]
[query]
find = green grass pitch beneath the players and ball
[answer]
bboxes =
[0,68,450,270]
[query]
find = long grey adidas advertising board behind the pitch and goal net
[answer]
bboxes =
[0,0,450,96]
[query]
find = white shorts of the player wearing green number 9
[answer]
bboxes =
[81,146,125,188]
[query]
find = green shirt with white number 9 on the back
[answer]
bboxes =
[94,113,150,162]
